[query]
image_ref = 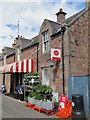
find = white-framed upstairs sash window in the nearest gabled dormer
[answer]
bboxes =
[42,30,49,53]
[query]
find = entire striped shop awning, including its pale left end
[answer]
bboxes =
[0,59,34,73]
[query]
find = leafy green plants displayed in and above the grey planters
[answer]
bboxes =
[25,72,52,101]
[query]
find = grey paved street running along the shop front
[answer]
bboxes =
[0,93,57,118]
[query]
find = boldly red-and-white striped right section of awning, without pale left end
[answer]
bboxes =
[10,59,34,73]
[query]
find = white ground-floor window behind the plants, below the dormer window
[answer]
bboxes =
[42,68,49,86]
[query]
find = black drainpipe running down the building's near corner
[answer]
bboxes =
[61,27,66,95]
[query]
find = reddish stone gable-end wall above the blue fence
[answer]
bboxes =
[69,12,89,76]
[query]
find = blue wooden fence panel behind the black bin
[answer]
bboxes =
[68,76,90,117]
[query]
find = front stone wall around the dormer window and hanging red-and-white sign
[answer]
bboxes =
[39,21,69,95]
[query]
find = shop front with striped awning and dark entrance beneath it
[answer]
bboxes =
[0,59,34,93]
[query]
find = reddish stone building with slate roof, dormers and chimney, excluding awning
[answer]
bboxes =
[0,2,90,110]
